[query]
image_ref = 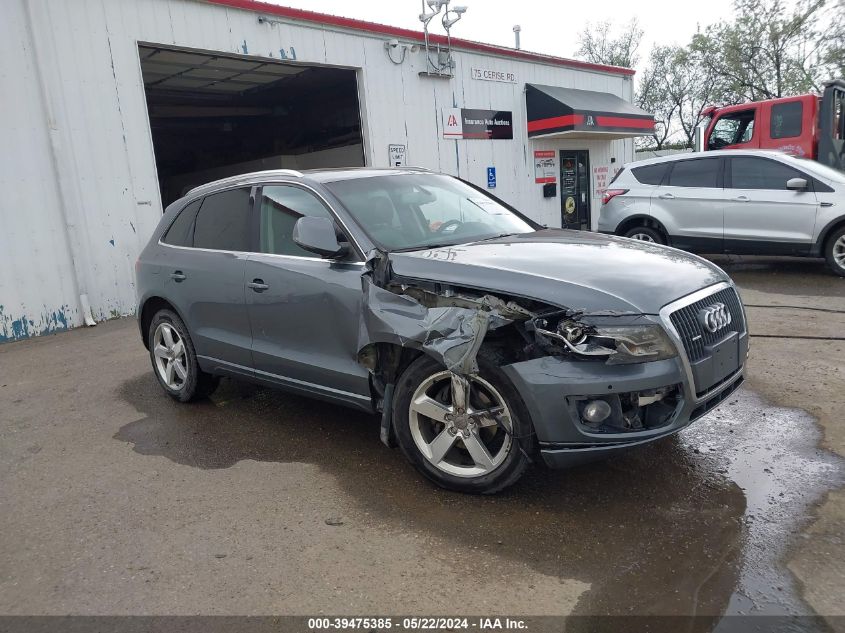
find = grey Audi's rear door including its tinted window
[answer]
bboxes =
[157,188,252,375]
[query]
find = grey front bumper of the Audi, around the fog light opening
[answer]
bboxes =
[502,357,743,468]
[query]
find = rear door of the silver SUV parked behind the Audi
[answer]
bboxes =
[651,157,725,253]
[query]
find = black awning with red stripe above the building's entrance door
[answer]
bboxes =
[525,84,654,138]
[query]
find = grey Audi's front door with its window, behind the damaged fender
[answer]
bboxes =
[239,184,370,404]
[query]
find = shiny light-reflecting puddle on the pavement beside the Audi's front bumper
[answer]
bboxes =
[680,390,845,630]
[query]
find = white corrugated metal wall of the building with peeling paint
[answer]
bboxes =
[0,0,633,342]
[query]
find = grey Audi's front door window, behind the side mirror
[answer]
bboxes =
[260,185,332,259]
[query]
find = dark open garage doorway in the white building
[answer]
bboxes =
[138,44,364,206]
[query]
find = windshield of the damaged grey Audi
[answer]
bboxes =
[326,174,534,251]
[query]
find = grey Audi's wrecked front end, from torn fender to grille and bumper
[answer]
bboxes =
[359,249,748,467]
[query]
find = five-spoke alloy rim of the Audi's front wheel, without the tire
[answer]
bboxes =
[408,371,513,477]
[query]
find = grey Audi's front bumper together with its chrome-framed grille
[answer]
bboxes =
[503,283,748,467]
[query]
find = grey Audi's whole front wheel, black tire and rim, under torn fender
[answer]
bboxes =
[393,356,534,494]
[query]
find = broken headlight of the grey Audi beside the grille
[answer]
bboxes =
[537,319,678,365]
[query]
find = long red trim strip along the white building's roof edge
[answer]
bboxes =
[199,0,636,76]
